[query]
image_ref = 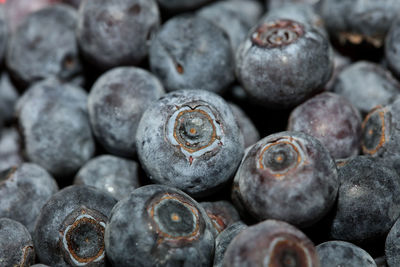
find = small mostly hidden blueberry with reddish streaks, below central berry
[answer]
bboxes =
[200,200,240,237]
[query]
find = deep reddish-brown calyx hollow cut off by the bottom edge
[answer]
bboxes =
[264,235,312,267]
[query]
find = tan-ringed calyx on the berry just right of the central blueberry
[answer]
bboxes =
[256,137,304,179]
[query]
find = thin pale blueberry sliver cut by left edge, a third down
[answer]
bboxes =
[0,72,18,122]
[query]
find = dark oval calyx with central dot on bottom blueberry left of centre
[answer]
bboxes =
[147,194,201,242]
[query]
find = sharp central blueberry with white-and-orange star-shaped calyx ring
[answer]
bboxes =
[136,90,244,197]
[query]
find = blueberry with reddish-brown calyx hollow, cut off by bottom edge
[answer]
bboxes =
[223,220,320,267]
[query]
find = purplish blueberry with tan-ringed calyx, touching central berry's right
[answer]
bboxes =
[233,132,339,227]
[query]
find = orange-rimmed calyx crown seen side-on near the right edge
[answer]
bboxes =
[361,106,387,155]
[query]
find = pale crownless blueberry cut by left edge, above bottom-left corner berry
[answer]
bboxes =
[0,163,58,233]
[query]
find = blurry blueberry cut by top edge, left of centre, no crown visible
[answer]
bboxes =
[76,0,160,70]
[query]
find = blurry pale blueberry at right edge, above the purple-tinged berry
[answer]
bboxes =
[333,61,400,112]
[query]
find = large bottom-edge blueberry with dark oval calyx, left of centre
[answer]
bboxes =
[105,185,214,267]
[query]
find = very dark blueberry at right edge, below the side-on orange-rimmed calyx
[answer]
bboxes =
[330,156,400,243]
